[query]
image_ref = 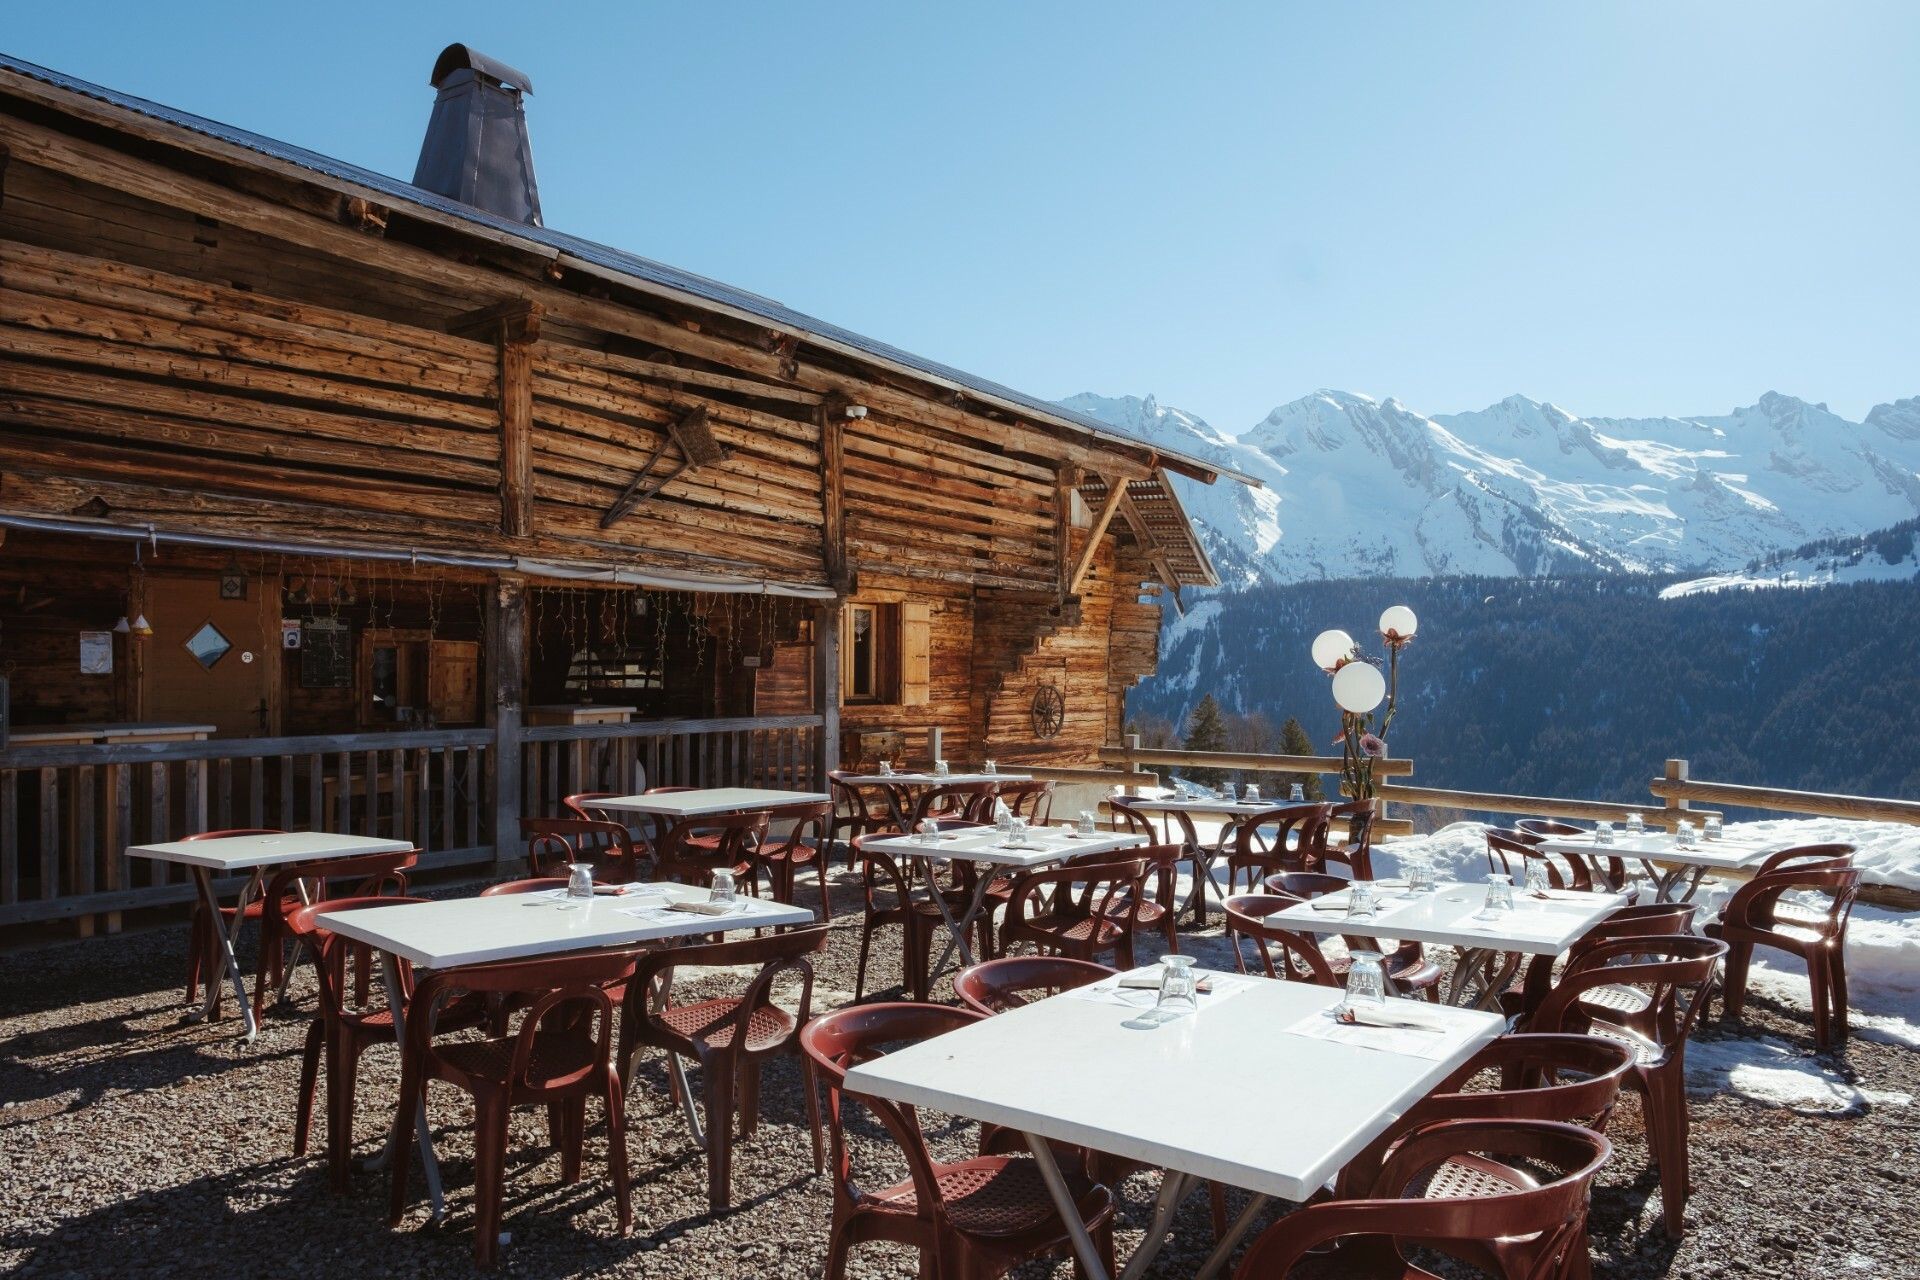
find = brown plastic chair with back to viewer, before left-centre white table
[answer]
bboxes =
[388,950,634,1267]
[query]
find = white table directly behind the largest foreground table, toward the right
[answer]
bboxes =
[1267,883,1626,1007]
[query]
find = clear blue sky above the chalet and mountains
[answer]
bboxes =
[0,0,1920,432]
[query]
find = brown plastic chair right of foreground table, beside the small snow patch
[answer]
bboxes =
[1526,935,1726,1238]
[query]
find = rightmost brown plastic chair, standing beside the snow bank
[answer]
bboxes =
[1707,844,1860,1052]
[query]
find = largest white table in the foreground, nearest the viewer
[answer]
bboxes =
[847,975,1505,1280]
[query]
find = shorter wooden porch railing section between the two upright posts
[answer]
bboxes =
[520,716,826,816]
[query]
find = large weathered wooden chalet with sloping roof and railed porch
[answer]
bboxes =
[0,46,1238,925]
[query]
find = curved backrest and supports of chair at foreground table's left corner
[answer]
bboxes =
[801,1004,985,1221]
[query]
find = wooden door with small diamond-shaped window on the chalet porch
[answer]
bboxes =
[140,574,280,737]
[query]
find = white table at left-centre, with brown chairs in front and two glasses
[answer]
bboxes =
[317,882,814,1219]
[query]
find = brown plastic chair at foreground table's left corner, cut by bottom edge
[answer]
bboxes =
[801,1004,1114,1280]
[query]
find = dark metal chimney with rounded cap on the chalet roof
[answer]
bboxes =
[413,44,540,226]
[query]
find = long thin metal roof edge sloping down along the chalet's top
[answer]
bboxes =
[0,54,1260,487]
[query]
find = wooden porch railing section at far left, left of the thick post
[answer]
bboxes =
[0,729,493,933]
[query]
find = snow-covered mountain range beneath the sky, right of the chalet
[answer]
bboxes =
[1064,383,1920,585]
